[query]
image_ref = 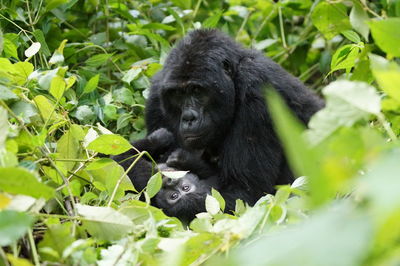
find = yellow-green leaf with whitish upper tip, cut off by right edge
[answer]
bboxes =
[369,54,400,102]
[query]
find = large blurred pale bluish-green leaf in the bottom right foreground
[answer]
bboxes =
[217,202,373,266]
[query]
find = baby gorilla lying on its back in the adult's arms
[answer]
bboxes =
[112,128,218,222]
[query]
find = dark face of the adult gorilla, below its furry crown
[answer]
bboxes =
[161,64,235,149]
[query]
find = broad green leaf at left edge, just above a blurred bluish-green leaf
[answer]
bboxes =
[0,167,54,199]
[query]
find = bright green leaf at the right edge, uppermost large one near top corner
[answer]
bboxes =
[368,18,400,57]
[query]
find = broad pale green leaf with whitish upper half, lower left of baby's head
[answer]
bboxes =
[76,204,134,241]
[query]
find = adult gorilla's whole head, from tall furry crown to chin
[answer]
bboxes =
[156,31,239,149]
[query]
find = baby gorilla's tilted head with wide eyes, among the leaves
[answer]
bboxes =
[154,168,211,222]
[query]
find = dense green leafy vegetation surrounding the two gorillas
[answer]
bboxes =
[0,0,400,266]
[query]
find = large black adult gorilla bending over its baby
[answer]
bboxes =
[146,30,323,206]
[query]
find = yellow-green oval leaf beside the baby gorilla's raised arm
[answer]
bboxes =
[88,134,132,155]
